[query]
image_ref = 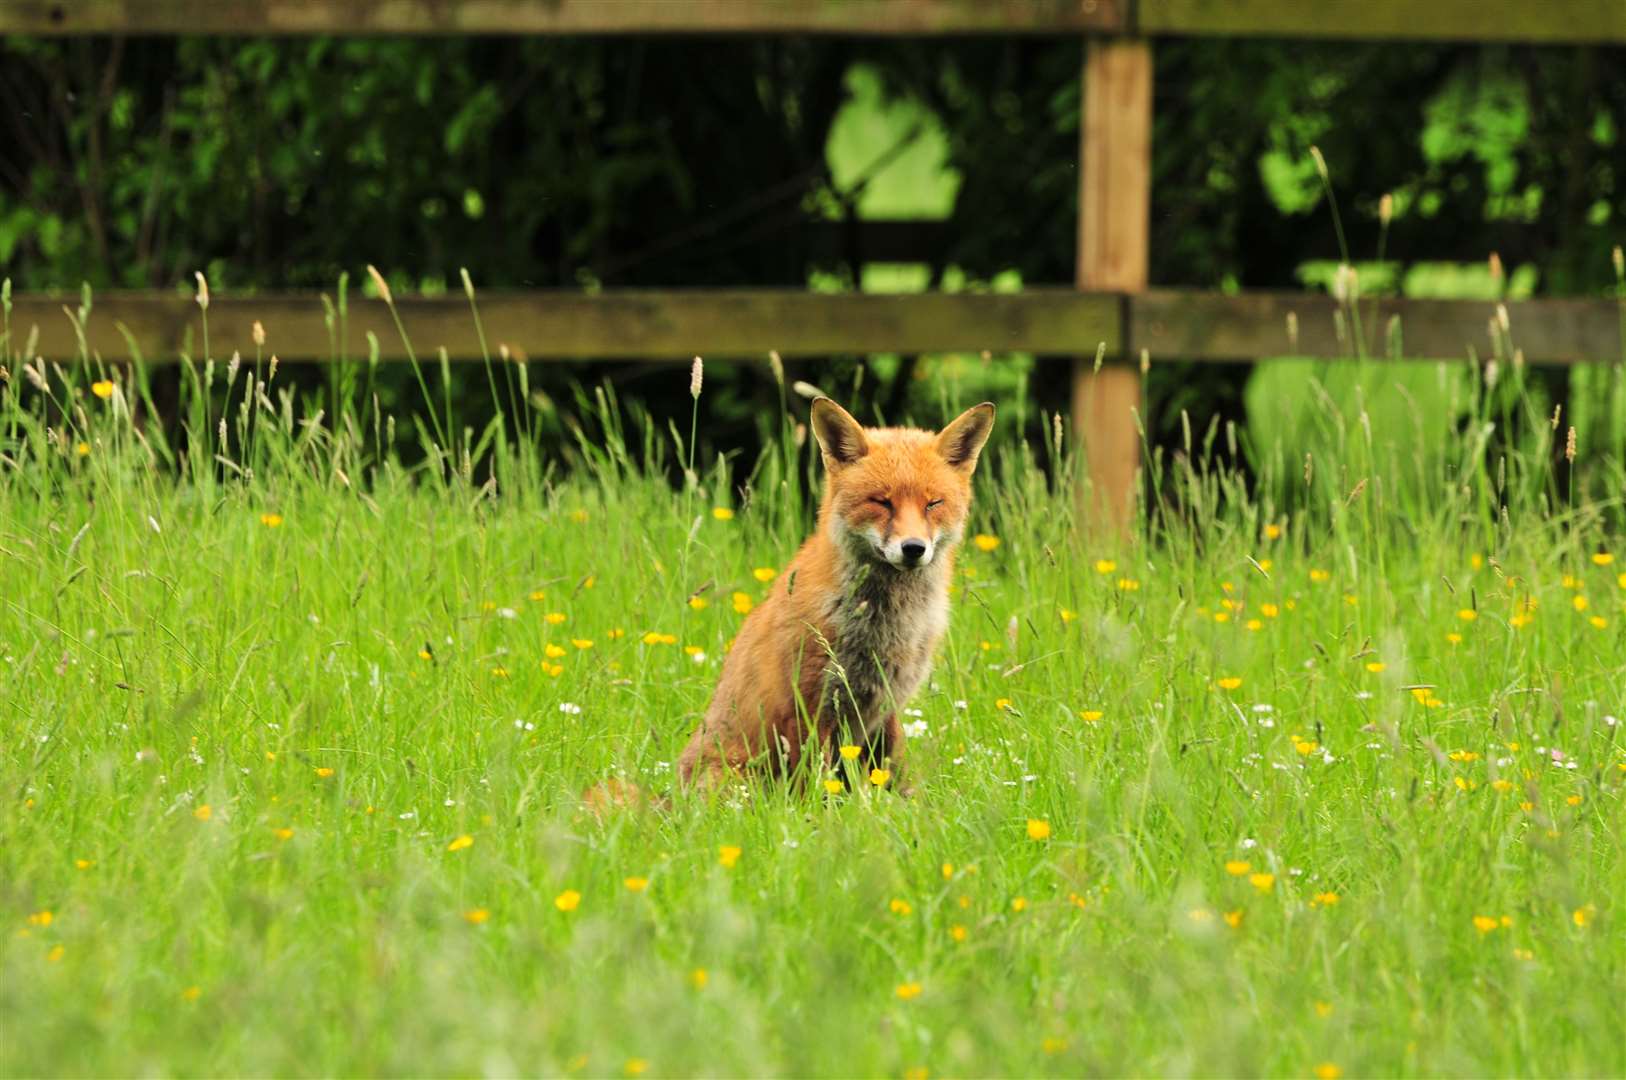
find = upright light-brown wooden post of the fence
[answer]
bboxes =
[1073,37,1151,538]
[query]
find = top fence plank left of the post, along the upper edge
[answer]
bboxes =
[0,0,1128,36]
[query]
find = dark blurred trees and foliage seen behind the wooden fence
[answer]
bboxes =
[0,37,1626,484]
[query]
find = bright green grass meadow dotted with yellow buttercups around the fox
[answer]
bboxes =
[0,279,1626,1080]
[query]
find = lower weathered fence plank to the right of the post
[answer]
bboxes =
[1128,290,1626,364]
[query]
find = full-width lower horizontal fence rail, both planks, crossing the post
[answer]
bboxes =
[11,288,1626,364]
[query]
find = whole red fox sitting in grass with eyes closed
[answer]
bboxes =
[678,397,993,787]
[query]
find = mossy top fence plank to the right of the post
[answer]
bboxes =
[1137,0,1626,44]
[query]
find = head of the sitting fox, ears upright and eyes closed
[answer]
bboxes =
[811,397,993,569]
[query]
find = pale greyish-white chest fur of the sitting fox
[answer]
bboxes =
[824,560,948,742]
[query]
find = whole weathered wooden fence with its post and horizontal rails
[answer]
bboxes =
[0,0,1626,529]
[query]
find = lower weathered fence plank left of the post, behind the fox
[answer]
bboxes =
[11,290,1120,361]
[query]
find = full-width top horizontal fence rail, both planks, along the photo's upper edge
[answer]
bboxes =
[12,0,1626,44]
